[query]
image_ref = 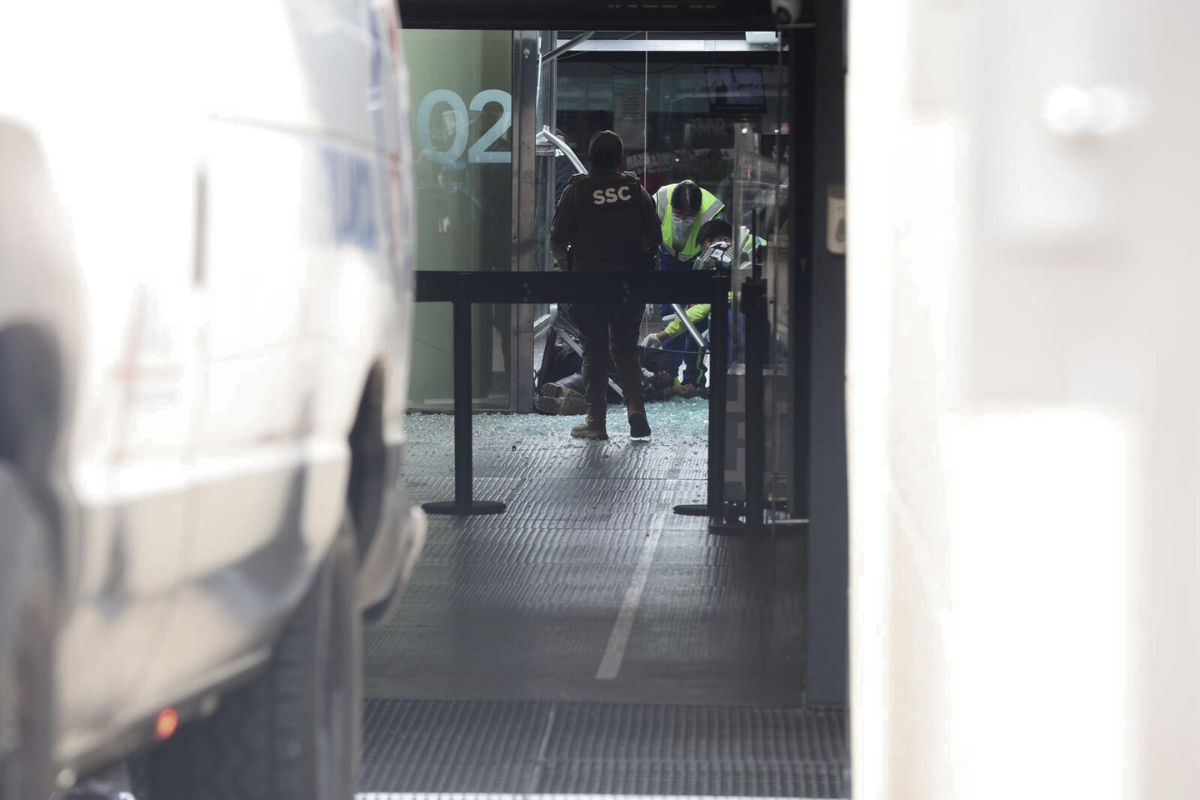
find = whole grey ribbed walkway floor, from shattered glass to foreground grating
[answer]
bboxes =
[360,408,848,800]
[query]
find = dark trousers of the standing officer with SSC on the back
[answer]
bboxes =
[566,303,646,420]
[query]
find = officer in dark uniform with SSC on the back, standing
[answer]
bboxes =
[550,131,662,439]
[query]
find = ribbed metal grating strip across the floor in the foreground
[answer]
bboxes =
[362,700,848,798]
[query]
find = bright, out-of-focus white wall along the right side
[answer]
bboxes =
[847,0,1200,800]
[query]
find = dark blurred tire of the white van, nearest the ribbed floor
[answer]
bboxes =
[134,521,362,800]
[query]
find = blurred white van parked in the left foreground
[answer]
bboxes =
[0,0,425,800]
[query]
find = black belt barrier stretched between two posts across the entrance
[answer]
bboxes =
[416,270,730,517]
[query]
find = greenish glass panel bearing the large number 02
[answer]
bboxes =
[403,30,512,410]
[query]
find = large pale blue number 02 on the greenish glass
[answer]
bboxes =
[416,89,512,164]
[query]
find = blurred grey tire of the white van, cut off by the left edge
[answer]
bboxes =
[0,463,54,800]
